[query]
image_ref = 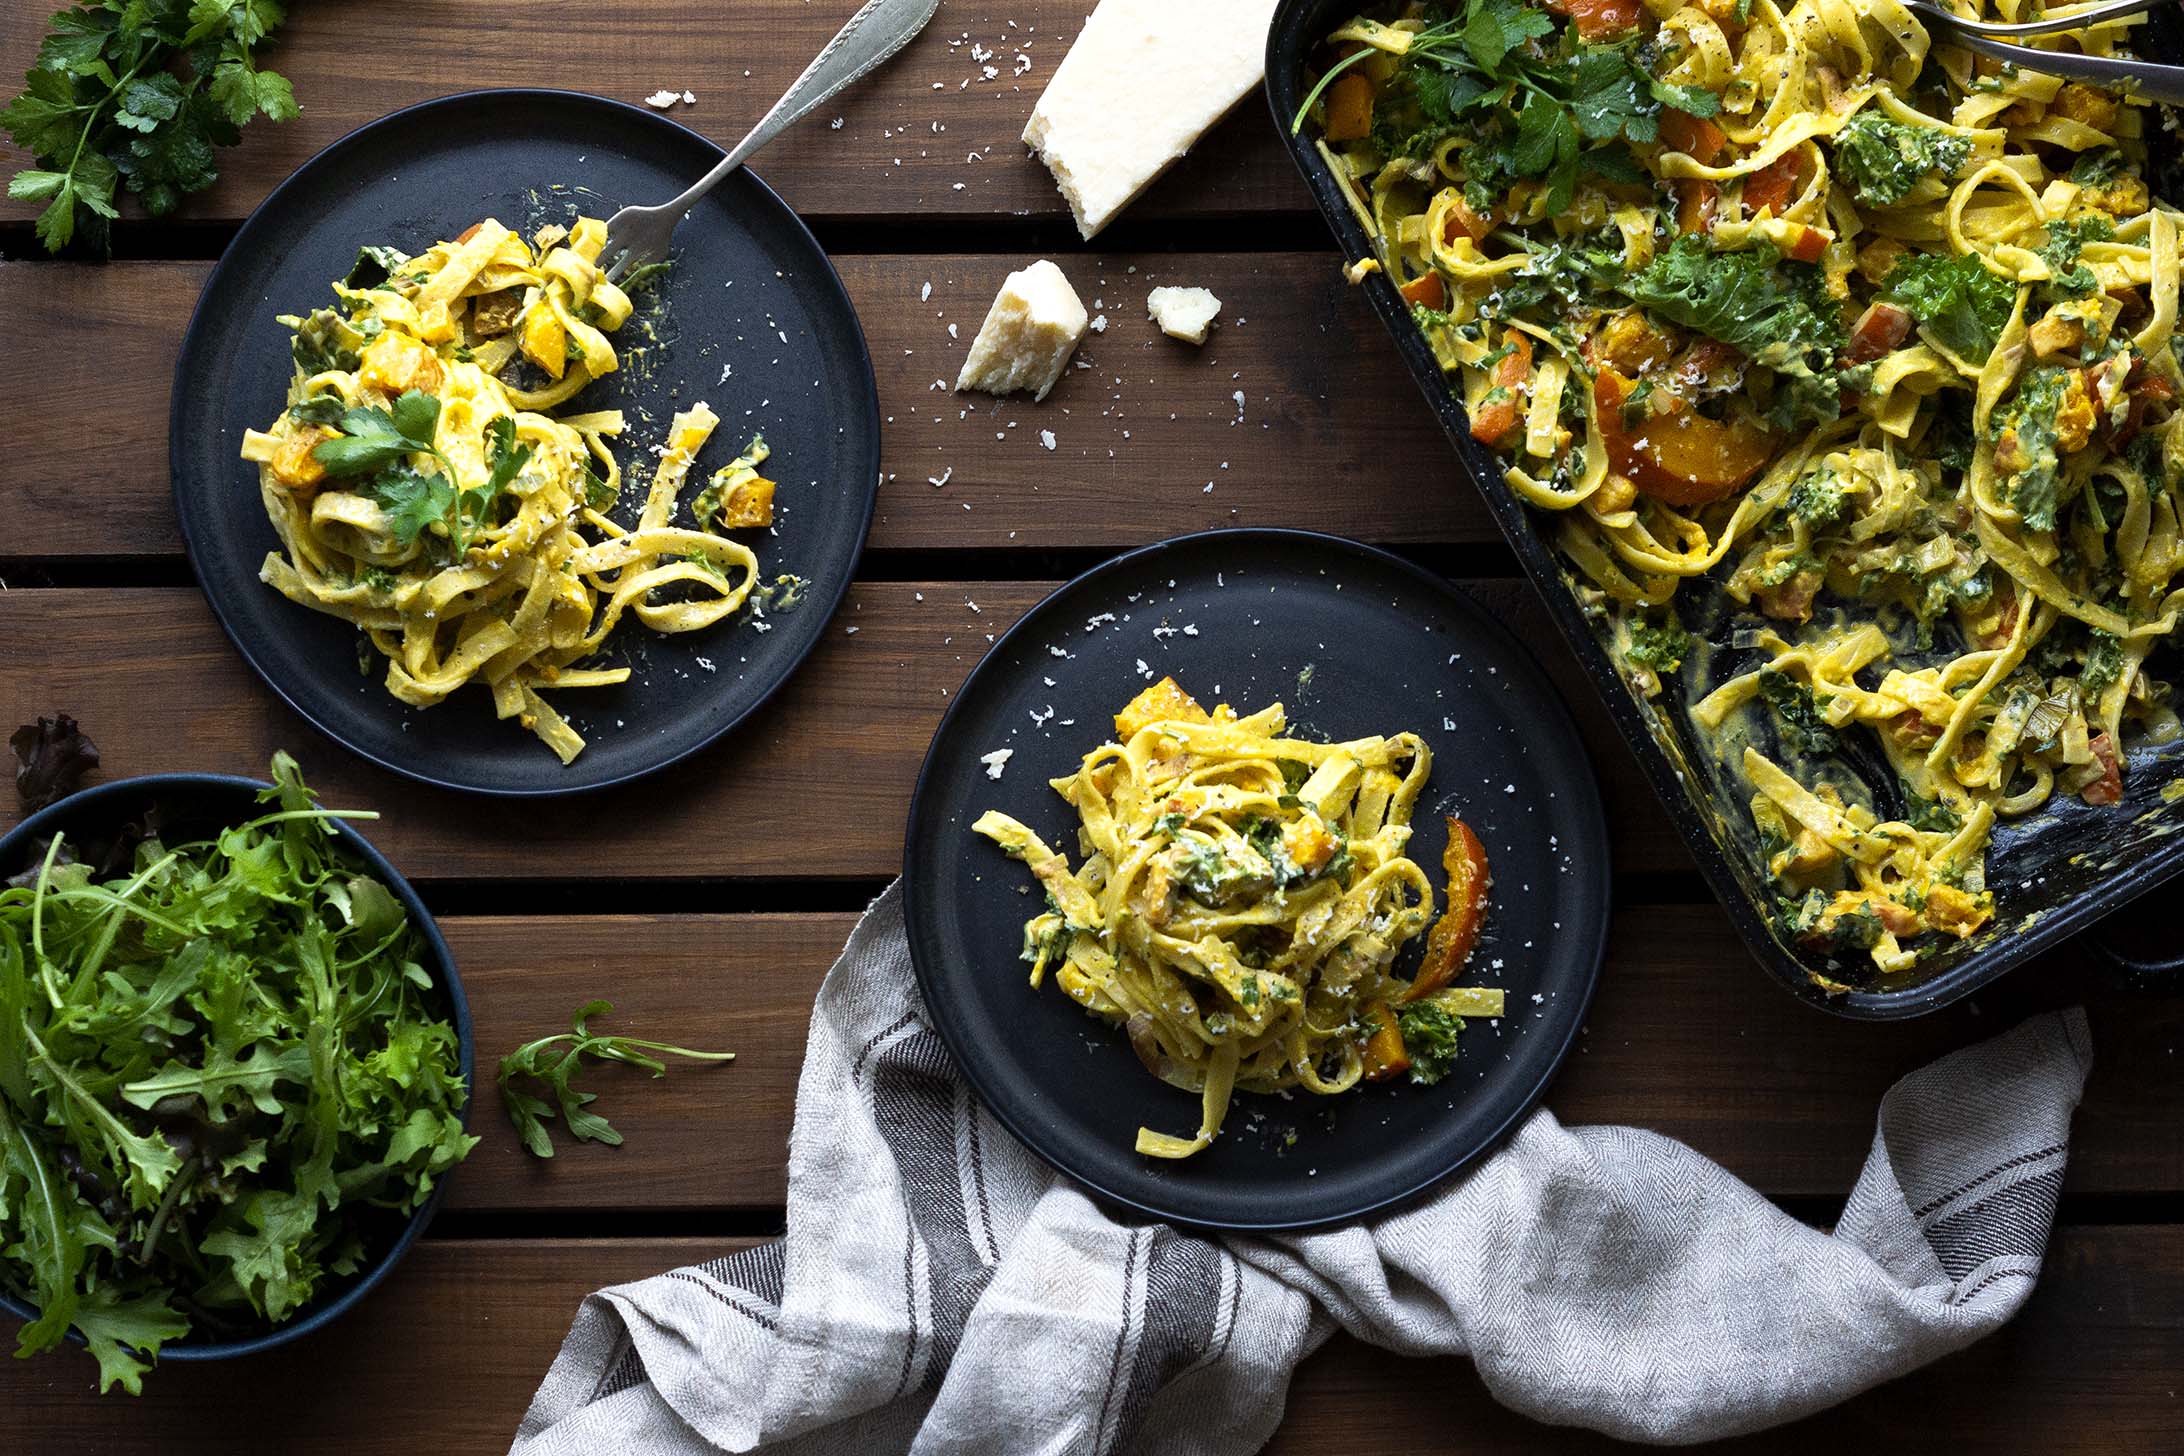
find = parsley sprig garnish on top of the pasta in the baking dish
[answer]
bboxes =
[1291,0,1721,212]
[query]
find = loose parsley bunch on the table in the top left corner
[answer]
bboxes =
[0,0,297,253]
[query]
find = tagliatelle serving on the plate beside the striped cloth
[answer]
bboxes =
[972,679,1503,1159]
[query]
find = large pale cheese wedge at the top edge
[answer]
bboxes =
[1024,0,1275,238]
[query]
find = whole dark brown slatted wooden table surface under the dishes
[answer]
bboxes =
[0,0,2184,1456]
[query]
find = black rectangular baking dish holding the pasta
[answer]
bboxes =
[1267,0,2184,1019]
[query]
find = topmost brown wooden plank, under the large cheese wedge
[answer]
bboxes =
[0,0,1310,236]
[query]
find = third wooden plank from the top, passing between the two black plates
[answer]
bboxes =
[0,581,1688,880]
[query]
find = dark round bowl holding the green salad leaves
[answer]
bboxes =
[0,773,476,1360]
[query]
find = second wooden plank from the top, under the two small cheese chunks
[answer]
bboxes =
[0,253,1500,559]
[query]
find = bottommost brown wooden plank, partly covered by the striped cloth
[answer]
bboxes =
[0,1227,2184,1456]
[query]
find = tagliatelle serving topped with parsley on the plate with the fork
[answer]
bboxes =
[242,218,795,764]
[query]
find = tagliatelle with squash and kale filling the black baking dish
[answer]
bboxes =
[1295,0,2184,978]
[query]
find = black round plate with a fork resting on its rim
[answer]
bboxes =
[170,92,880,795]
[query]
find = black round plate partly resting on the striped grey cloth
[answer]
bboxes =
[904,530,1607,1229]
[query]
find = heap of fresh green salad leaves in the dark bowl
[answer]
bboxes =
[0,753,476,1395]
